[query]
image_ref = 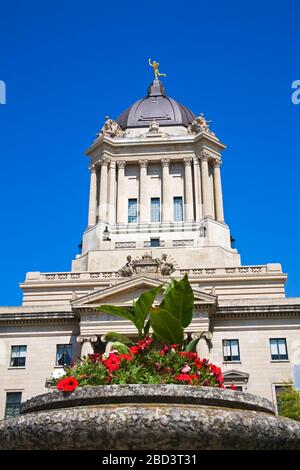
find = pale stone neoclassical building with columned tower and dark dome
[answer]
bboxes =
[0,78,300,419]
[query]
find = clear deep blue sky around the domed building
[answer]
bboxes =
[0,0,300,305]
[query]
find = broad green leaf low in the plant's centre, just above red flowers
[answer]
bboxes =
[150,309,183,344]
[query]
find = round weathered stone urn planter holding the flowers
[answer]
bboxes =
[0,385,300,450]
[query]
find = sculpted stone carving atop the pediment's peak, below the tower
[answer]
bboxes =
[118,253,175,277]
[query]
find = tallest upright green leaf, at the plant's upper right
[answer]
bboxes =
[159,274,194,328]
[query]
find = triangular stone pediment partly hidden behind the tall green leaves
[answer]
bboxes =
[71,276,217,311]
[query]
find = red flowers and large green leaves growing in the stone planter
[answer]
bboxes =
[55,276,235,392]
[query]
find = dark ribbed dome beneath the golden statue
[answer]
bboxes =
[116,80,195,130]
